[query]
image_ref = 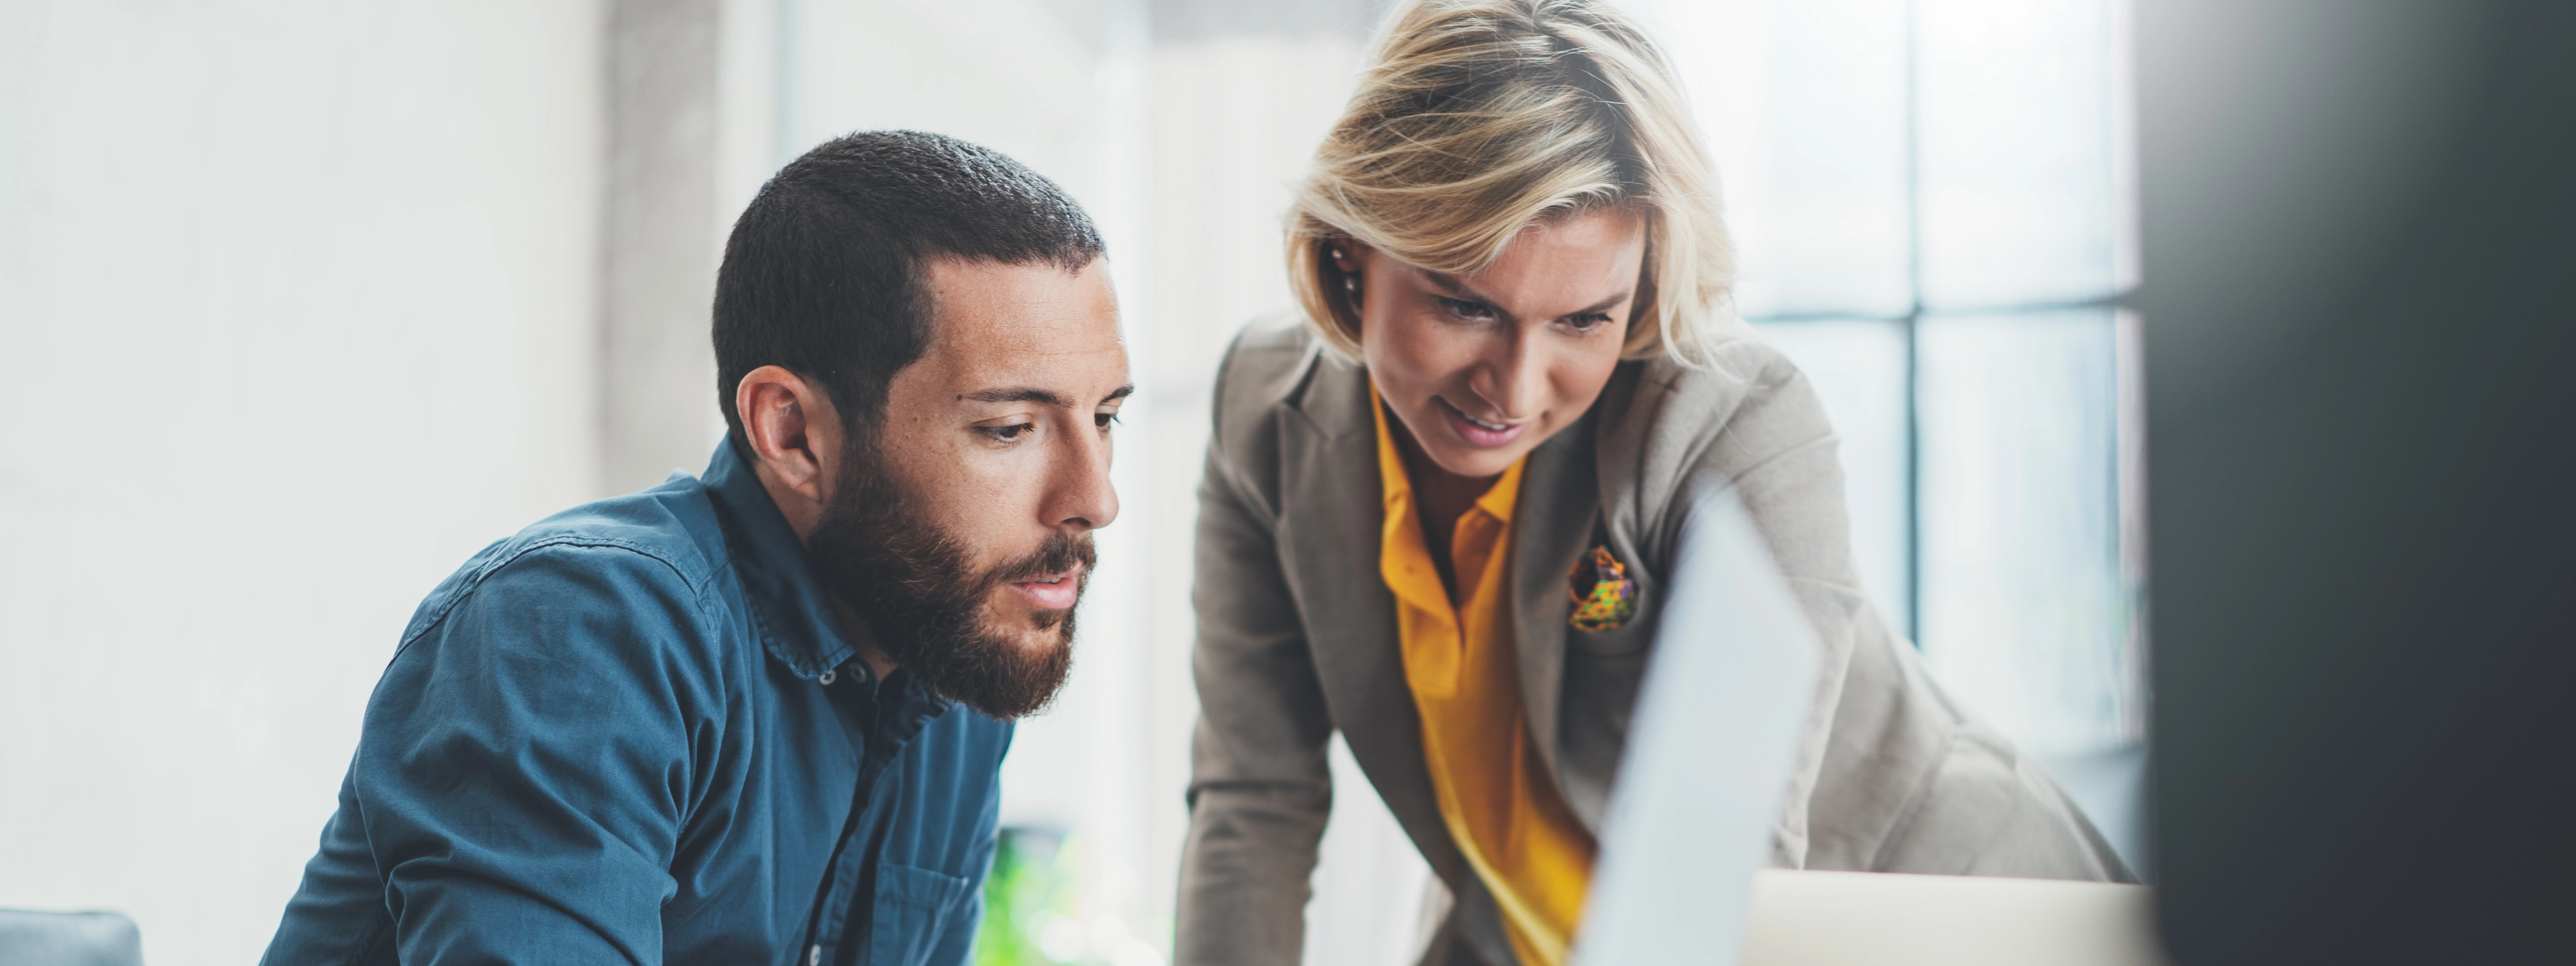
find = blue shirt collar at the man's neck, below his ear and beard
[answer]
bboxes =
[698,433,868,678]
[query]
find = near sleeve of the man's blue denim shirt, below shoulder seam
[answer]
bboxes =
[350,543,721,963]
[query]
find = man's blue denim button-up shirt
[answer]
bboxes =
[263,441,1012,966]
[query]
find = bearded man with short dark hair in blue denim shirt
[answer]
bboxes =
[266,131,1128,966]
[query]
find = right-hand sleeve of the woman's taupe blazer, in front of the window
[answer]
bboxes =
[1682,343,2135,881]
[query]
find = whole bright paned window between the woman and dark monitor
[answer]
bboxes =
[1641,0,2146,861]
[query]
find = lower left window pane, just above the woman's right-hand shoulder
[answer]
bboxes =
[1762,319,1914,634]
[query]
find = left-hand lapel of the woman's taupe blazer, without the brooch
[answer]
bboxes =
[1278,353,1468,889]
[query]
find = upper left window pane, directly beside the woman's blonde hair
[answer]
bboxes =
[1638,0,1914,317]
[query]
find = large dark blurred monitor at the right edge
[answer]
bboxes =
[2135,0,2576,966]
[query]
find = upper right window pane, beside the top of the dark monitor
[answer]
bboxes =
[1917,0,2125,309]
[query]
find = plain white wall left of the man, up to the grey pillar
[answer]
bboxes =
[0,0,600,966]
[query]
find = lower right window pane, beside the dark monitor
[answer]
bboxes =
[1917,312,2141,755]
